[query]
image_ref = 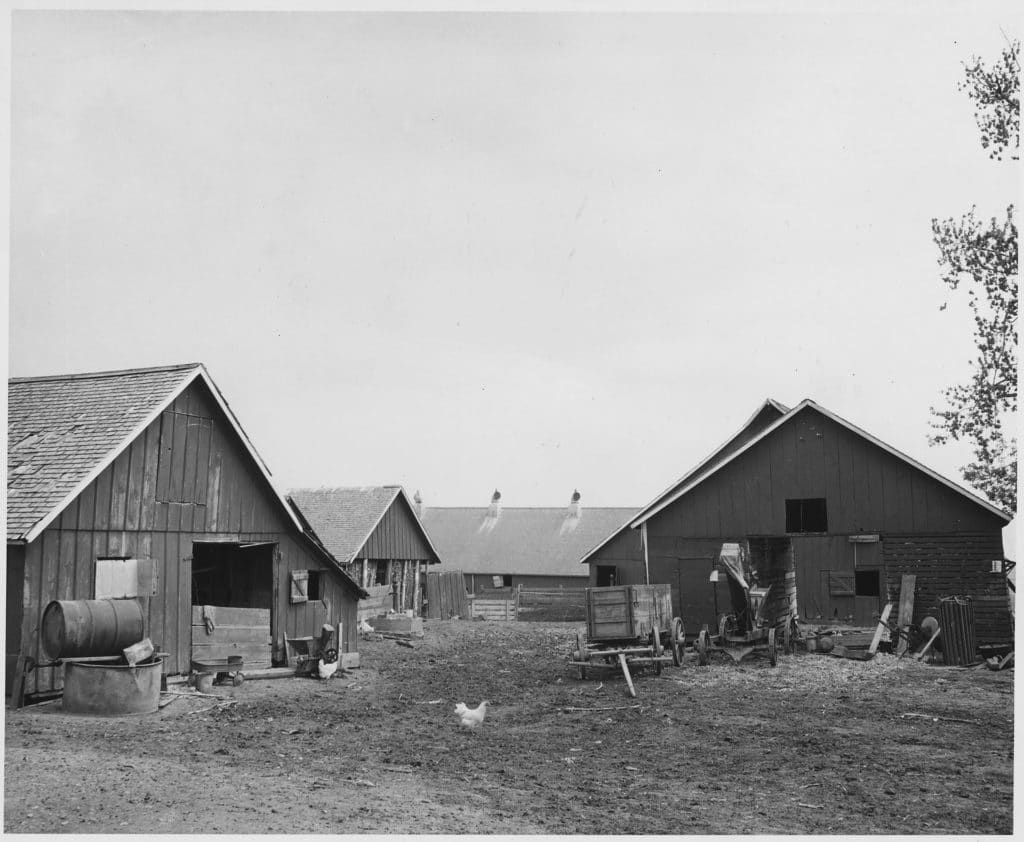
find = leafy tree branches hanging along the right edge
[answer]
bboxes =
[929,41,1020,512]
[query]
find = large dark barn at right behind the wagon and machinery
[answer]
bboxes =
[583,401,1012,642]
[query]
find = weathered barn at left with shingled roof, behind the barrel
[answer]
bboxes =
[6,364,366,694]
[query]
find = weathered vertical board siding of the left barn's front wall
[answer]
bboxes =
[14,383,358,693]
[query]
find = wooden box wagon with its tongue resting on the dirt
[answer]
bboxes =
[569,585,686,697]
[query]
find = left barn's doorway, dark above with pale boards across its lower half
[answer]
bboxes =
[191,541,276,669]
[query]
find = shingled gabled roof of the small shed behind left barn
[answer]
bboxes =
[288,486,439,563]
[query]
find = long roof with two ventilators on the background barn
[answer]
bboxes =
[421,507,637,576]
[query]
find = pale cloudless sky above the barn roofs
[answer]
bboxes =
[9,3,1022,549]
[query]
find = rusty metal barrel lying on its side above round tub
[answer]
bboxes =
[41,599,145,661]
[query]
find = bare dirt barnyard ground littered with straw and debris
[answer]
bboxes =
[4,621,1013,834]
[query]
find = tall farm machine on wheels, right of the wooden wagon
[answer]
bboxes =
[695,544,798,667]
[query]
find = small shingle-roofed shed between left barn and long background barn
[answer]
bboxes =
[288,486,440,616]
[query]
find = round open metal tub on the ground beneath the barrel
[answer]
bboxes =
[63,658,164,716]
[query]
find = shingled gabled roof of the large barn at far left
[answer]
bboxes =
[7,363,302,542]
